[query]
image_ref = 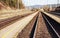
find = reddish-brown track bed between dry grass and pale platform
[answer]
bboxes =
[0,14,30,30]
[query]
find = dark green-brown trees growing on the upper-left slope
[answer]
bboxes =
[0,0,24,9]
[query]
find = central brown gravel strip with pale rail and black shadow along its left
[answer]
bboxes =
[25,12,50,38]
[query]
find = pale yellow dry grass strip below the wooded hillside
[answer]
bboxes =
[0,9,33,19]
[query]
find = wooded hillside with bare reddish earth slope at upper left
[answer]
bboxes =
[0,0,24,9]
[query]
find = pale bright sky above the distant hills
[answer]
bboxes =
[22,0,60,6]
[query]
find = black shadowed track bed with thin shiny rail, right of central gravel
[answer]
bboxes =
[42,13,60,38]
